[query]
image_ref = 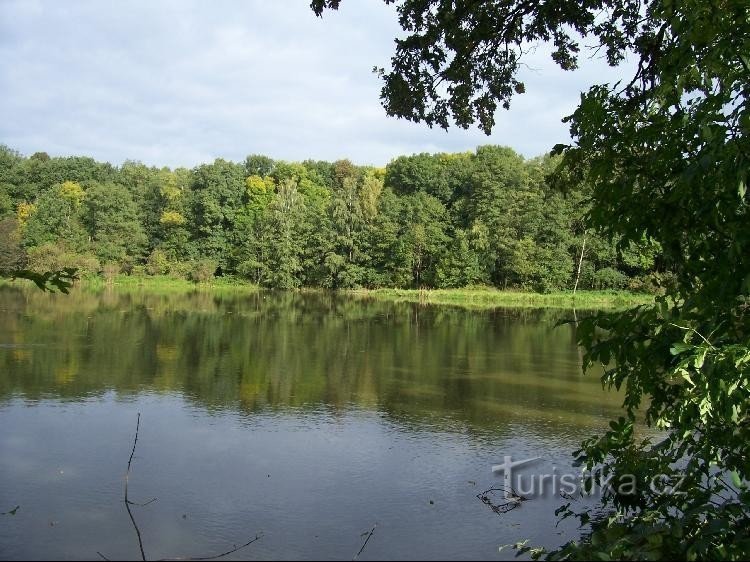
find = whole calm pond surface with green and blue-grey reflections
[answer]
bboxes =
[0,287,620,560]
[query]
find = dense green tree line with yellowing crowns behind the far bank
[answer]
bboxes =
[0,146,665,291]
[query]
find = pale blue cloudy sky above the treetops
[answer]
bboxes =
[0,0,636,167]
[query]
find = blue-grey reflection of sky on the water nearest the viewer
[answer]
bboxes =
[0,393,596,559]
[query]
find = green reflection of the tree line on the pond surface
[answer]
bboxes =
[0,288,619,427]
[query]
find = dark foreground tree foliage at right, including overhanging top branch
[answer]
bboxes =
[312,0,750,560]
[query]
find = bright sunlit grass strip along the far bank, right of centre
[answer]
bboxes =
[351,287,653,308]
